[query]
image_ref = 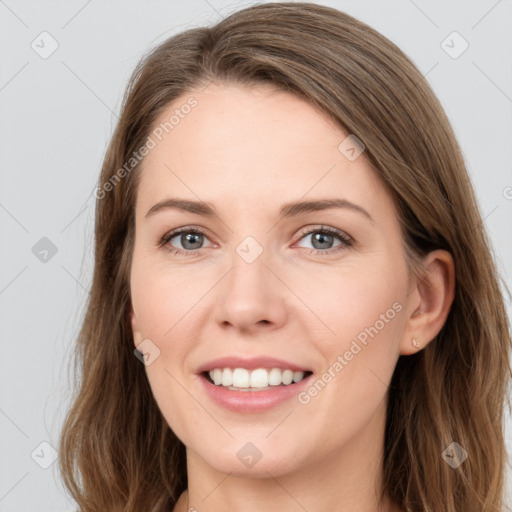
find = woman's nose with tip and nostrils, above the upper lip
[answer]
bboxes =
[215,245,287,334]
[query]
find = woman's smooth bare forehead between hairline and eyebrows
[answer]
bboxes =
[137,84,390,218]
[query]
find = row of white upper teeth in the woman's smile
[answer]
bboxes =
[210,368,304,388]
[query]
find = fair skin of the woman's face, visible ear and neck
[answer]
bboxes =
[130,84,454,512]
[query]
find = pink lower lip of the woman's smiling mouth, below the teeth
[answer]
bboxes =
[199,374,313,413]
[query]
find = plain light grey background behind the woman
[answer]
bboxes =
[0,0,512,512]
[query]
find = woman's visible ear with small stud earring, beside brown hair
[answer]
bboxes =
[400,250,455,355]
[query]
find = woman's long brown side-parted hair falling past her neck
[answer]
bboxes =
[60,3,511,512]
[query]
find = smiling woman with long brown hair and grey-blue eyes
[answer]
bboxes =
[60,3,510,512]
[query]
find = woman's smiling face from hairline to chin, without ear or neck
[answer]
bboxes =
[131,84,411,476]
